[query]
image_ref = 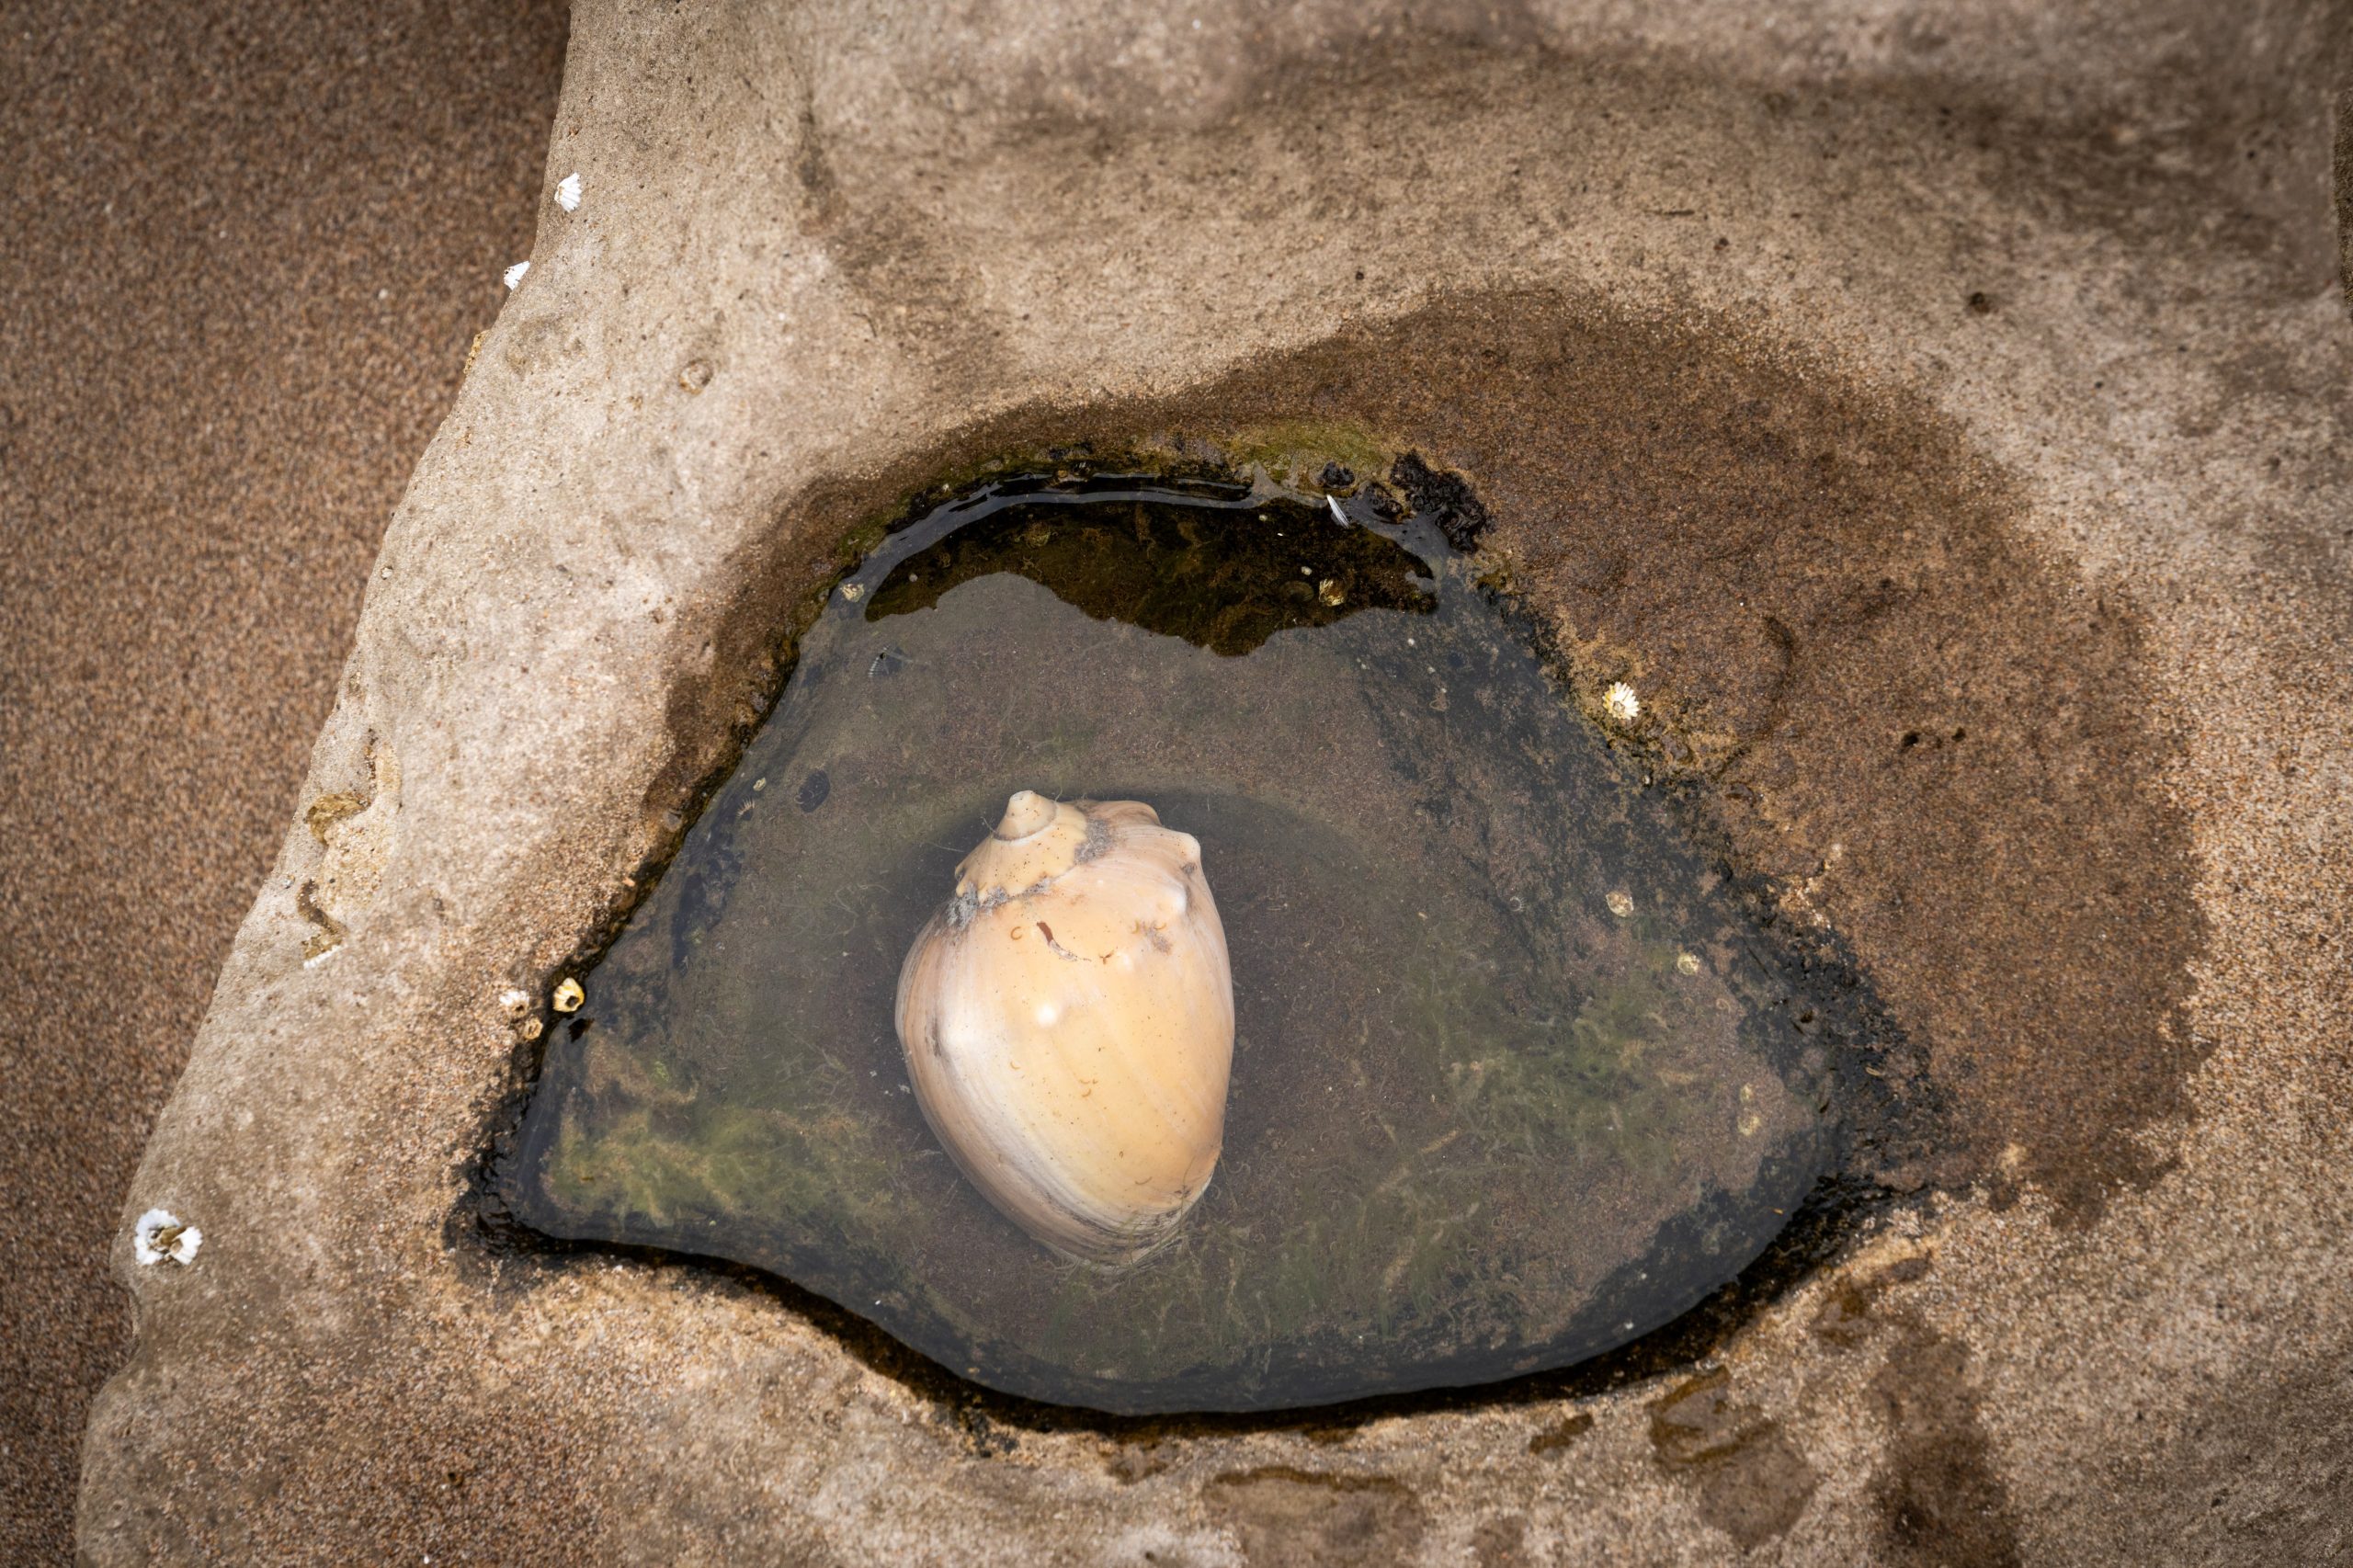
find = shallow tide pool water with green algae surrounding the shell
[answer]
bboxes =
[499,471,1833,1413]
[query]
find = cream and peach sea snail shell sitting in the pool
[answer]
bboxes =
[896,789,1233,1265]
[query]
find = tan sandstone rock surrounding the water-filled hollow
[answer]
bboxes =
[80,0,2353,1563]
